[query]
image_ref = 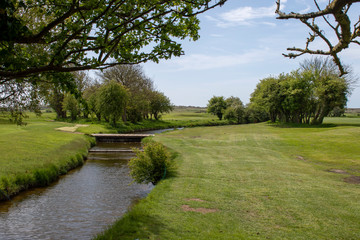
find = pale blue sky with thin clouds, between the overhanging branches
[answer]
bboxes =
[143,0,360,108]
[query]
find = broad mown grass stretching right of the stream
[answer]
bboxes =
[97,118,360,239]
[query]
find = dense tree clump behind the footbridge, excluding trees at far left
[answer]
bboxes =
[56,65,173,126]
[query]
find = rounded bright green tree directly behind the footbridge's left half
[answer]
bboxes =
[97,81,128,126]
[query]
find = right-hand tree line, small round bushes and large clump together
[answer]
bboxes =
[207,58,356,124]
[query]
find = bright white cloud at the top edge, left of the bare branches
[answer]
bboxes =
[206,1,280,28]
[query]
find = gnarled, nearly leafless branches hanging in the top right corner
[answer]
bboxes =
[276,0,360,76]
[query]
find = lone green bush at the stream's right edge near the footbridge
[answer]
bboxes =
[128,141,173,185]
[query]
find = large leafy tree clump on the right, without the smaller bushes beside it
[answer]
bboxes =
[250,59,349,124]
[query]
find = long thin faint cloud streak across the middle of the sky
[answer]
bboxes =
[161,48,274,72]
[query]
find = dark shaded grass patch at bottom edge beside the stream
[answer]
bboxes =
[95,206,166,240]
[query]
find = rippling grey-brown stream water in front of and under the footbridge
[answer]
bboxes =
[0,143,152,240]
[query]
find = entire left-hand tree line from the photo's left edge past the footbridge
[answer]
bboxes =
[0,65,173,125]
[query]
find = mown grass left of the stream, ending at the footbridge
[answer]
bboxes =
[0,114,92,199]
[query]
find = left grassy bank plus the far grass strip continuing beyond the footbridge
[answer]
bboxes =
[0,109,229,200]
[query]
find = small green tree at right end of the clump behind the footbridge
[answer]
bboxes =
[150,91,174,120]
